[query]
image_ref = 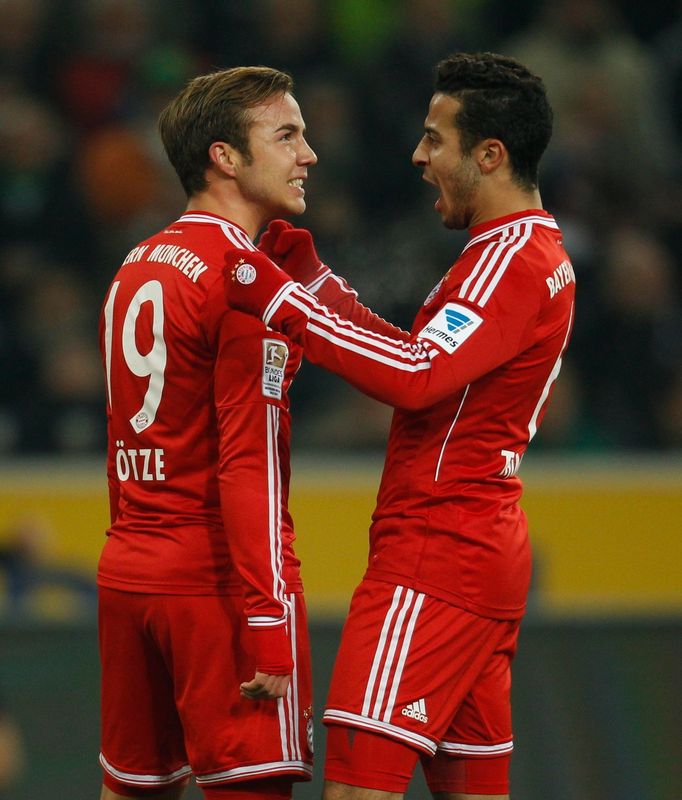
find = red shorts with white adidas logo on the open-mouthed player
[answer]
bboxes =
[324,580,519,758]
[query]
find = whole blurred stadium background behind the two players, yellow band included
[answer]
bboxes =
[0,0,682,800]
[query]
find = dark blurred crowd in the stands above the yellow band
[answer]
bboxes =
[0,0,682,456]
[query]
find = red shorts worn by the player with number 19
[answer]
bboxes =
[99,588,312,791]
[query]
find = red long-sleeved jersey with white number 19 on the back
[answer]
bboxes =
[98,212,301,648]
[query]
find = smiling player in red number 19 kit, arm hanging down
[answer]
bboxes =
[98,67,317,800]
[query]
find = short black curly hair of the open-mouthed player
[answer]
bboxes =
[434,53,553,189]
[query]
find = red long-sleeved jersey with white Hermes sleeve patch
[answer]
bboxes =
[264,210,575,619]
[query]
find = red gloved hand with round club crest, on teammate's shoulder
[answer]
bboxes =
[225,250,293,319]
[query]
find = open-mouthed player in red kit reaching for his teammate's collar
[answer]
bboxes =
[226,53,575,800]
